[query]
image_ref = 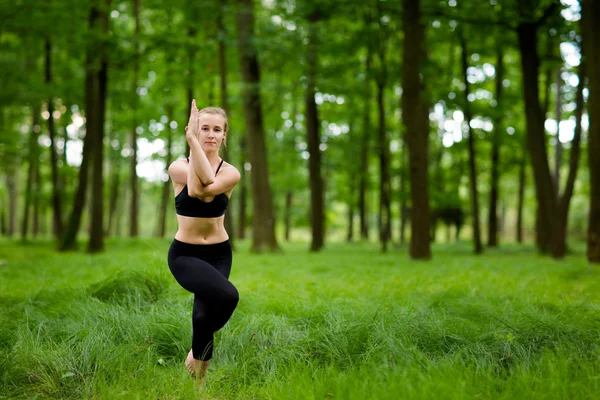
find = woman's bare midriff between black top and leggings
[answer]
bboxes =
[175,215,229,244]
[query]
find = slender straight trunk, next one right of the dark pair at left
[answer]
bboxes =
[129,0,140,237]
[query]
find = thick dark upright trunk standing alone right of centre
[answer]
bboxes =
[402,0,431,259]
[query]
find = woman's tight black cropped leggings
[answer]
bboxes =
[168,239,239,361]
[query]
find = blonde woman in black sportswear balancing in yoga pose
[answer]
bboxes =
[168,100,240,379]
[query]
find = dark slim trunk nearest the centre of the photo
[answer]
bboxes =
[305,11,325,251]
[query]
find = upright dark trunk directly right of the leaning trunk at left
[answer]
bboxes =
[86,0,110,253]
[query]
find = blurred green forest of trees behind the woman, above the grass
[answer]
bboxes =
[0,0,600,262]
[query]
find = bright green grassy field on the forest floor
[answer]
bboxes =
[0,239,600,399]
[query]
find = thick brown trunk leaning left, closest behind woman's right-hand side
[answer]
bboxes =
[236,0,279,252]
